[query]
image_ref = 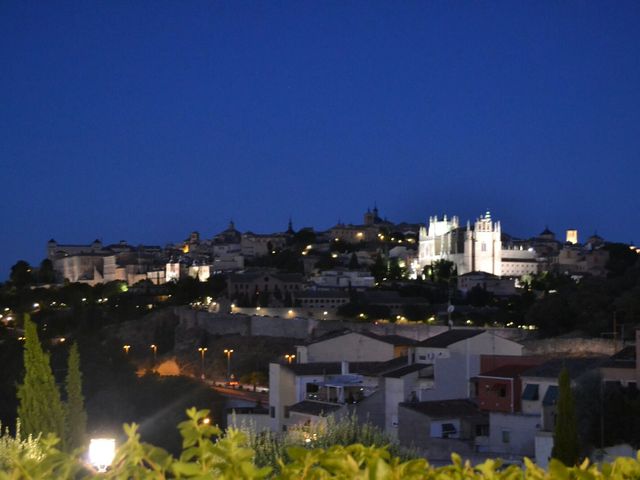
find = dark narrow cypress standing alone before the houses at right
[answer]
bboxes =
[551,367,580,466]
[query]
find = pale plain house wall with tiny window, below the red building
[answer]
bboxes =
[489,412,540,457]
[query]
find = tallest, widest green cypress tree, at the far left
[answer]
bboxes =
[18,315,64,439]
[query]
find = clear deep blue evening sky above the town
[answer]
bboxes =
[0,0,640,279]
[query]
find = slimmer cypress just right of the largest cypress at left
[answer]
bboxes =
[65,343,87,451]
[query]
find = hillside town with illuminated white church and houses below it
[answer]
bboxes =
[2,208,640,466]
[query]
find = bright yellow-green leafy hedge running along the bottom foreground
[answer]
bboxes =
[0,409,640,480]
